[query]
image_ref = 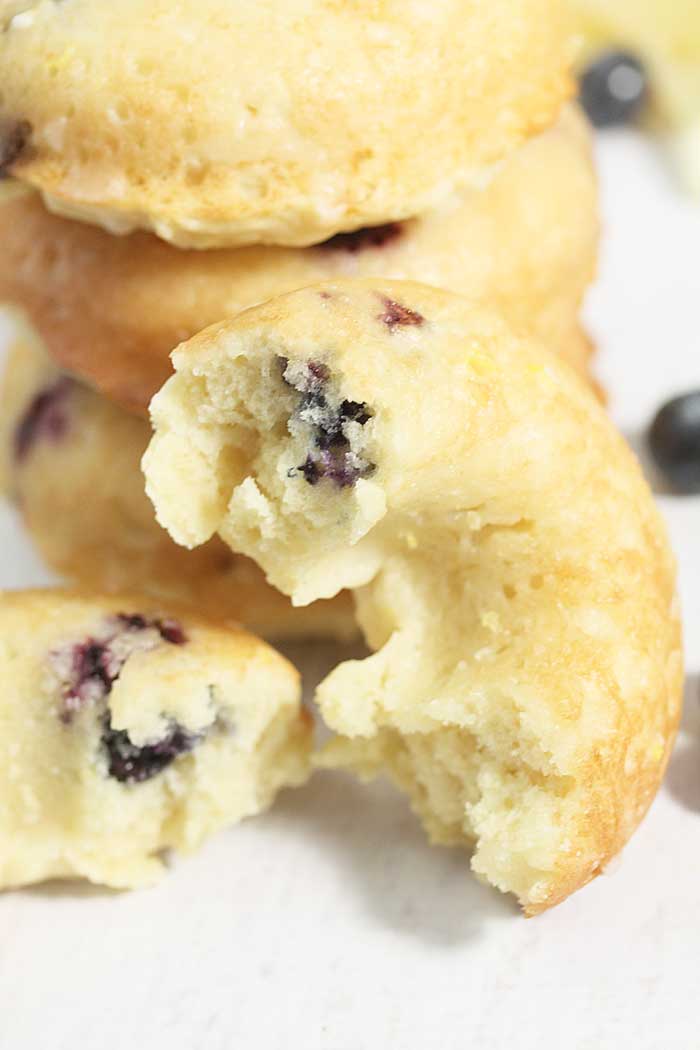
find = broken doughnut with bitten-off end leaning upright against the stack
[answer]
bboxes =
[144,280,682,915]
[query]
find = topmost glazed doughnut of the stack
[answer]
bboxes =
[0,0,572,248]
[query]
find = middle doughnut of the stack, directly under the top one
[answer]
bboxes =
[0,107,598,414]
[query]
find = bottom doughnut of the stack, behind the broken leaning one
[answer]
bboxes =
[0,330,357,641]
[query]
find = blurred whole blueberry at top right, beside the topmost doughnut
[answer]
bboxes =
[579,50,649,128]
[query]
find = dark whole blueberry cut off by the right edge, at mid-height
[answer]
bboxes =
[649,390,700,495]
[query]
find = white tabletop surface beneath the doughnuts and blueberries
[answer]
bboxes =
[0,135,700,1050]
